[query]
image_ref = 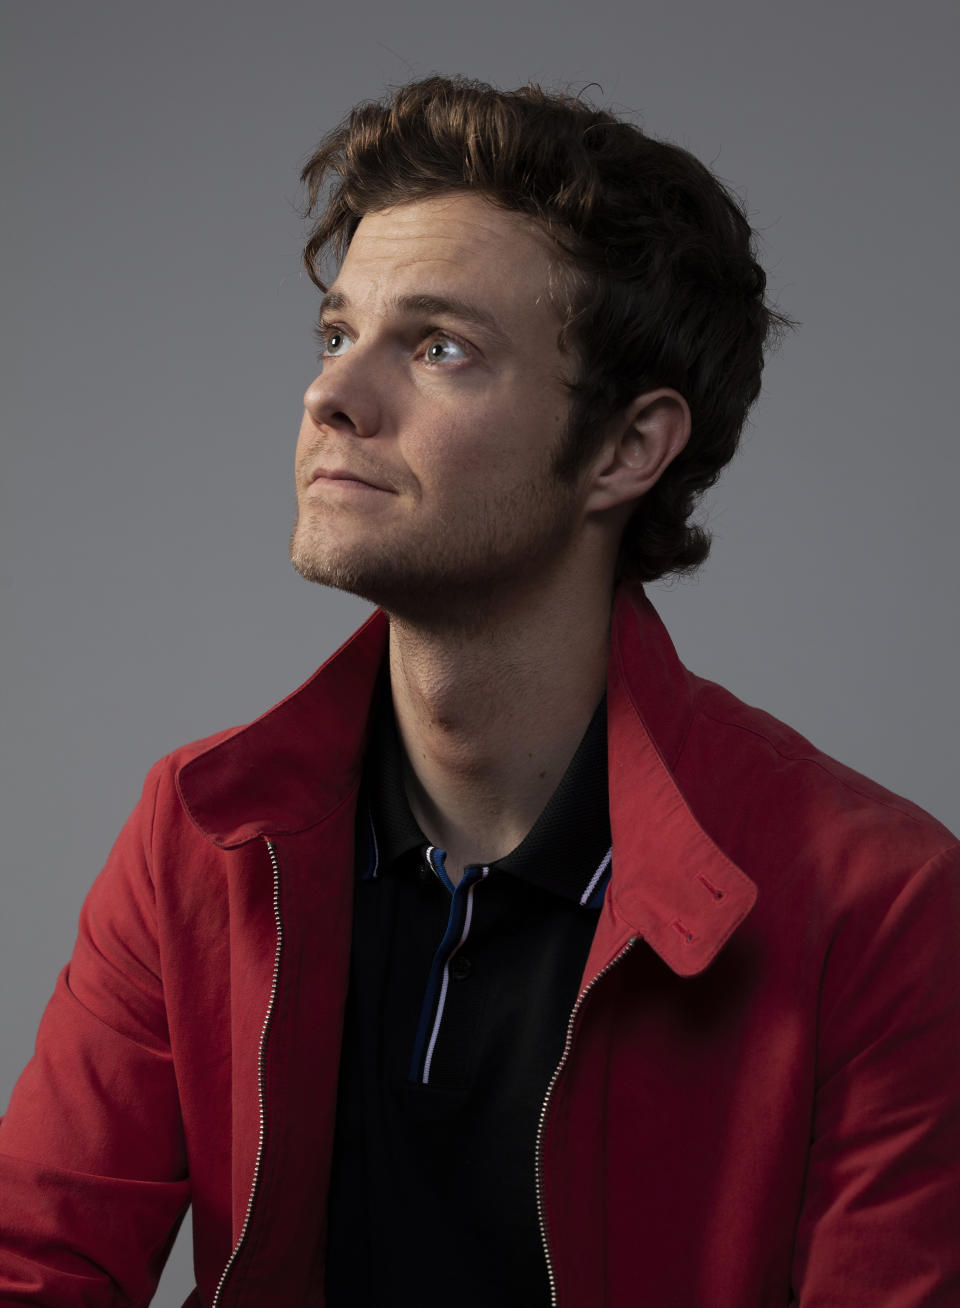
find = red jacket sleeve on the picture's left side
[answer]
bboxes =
[0,765,190,1308]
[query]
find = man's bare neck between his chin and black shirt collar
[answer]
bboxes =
[390,570,611,880]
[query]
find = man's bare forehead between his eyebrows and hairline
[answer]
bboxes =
[331,192,558,335]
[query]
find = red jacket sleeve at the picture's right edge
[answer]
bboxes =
[794,846,960,1308]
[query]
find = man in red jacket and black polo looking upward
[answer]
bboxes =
[0,78,960,1308]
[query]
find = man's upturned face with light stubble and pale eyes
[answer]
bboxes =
[290,194,579,615]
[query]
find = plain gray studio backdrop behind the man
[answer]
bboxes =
[0,0,960,1305]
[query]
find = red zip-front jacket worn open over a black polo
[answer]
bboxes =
[0,589,960,1308]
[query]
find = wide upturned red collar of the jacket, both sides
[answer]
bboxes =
[177,585,756,976]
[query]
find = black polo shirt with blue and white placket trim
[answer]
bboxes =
[326,689,611,1308]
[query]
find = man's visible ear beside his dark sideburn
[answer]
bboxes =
[585,386,691,511]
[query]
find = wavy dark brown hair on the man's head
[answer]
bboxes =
[301,76,789,581]
